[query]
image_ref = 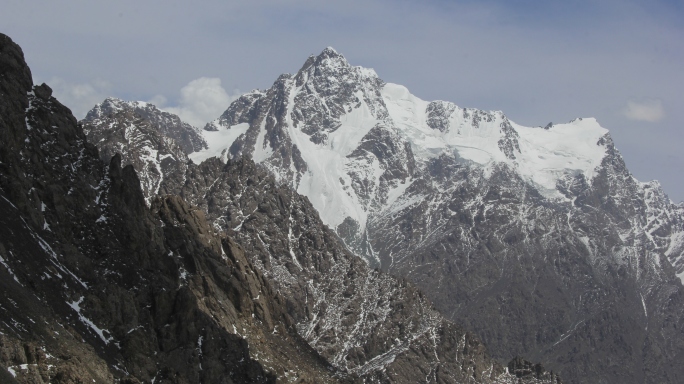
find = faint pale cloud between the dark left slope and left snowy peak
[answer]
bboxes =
[46,77,111,120]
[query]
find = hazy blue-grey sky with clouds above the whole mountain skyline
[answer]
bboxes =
[0,0,684,201]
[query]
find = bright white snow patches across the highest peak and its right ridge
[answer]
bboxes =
[196,60,608,236]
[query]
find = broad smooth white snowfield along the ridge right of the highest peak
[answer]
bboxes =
[381,83,608,196]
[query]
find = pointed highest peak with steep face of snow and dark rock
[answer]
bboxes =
[193,48,396,238]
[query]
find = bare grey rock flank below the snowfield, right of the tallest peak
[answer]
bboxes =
[372,139,684,382]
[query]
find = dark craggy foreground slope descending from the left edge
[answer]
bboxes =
[0,35,347,383]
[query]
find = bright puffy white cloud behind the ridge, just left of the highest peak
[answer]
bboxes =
[158,77,240,128]
